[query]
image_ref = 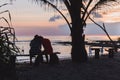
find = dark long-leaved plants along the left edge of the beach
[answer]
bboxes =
[0,3,19,80]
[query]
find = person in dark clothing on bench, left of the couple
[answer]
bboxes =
[29,35,43,64]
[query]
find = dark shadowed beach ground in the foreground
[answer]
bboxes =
[16,54,120,80]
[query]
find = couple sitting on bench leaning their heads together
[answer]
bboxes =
[29,35,53,64]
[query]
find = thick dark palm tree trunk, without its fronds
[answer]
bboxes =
[71,0,87,62]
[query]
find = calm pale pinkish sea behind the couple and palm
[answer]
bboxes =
[16,35,118,62]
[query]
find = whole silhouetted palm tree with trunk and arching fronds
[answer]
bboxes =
[34,0,115,62]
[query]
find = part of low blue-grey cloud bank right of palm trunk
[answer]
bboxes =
[85,22,120,35]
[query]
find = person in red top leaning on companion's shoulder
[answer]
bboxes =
[42,38,53,63]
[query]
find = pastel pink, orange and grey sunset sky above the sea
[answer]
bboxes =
[0,0,120,35]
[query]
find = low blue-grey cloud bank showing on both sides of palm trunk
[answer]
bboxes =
[59,22,120,35]
